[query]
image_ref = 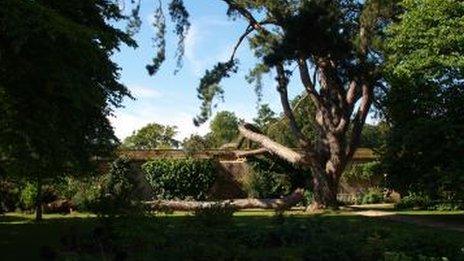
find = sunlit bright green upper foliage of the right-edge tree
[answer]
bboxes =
[386,0,464,81]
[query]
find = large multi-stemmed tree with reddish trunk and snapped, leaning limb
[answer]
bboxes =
[149,0,395,208]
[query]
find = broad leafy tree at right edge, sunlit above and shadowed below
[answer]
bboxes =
[382,0,464,200]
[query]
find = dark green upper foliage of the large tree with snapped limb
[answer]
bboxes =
[189,0,395,123]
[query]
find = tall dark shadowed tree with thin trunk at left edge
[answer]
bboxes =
[0,0,136,219]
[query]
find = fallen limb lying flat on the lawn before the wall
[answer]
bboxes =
[145,189,304,211]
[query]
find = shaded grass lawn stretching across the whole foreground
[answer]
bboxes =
[0,210,464,260]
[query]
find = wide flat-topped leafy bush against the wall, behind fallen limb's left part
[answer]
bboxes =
[142,158,216,200]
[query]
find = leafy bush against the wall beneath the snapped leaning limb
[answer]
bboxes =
[245,154,310,198]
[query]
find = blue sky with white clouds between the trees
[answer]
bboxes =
[110,1,300,139]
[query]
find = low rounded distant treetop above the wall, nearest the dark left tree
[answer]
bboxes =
[122,123,179,150]
